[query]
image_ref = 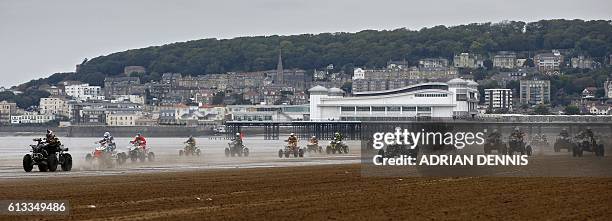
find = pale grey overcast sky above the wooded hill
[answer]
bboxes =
[0,0,612,87]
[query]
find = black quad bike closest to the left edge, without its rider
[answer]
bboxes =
[23,138,72,172]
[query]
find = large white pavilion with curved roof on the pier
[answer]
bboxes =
[309,78,478,121]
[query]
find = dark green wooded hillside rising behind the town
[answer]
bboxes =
[8,20,612,108]
